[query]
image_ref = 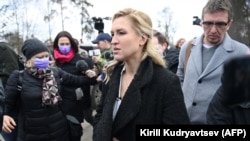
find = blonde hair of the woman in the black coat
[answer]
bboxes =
[105,8,166,82]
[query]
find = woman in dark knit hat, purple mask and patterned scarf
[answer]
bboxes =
[2,39,96,141]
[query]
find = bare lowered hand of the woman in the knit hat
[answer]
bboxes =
[2,115,16,133]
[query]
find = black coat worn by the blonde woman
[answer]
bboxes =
[93,58,189,141]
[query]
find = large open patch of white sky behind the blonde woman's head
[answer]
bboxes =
[79,0,207,44]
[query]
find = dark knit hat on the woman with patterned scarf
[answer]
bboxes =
[22,39,49,60]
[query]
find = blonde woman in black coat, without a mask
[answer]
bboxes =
[93,8,189,141]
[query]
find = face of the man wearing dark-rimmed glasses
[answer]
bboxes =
[202,11,231,45]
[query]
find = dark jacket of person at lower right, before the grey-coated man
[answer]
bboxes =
[207,87,250,125]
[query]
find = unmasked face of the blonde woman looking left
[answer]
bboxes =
[111,17,146,61]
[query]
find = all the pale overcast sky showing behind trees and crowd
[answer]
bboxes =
[0,0,207,44]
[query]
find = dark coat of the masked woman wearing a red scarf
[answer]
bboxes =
[56,54,97,123]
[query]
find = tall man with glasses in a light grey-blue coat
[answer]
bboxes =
[177,0,249,124]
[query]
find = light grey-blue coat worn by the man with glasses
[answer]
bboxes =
[176,34,249,124]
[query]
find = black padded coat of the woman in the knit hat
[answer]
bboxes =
[4,68,95,141]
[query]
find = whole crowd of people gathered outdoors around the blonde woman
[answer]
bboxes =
[0,0,250,141]
